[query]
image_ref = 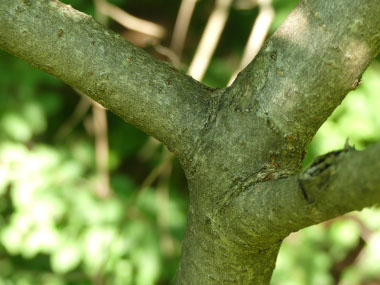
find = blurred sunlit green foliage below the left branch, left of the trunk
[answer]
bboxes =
[0,40,187,284]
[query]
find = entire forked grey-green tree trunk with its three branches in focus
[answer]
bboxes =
[0,0,380,284]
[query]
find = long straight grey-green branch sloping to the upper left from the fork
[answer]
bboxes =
[0,0,212,154]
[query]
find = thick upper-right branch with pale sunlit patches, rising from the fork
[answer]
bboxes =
[231,0,380,152]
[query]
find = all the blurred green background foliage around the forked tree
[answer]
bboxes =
[0,0,380,285]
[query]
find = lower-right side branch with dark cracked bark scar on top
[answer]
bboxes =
[220,142,380,242]
